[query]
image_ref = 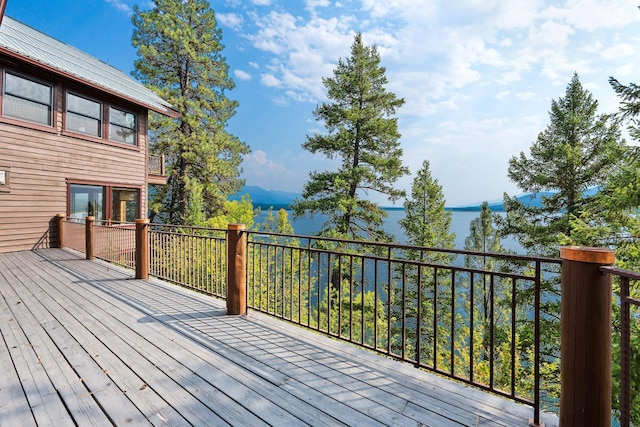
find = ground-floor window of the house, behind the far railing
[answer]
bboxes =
[69,184,140,222]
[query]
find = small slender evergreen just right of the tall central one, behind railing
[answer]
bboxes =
[390,160,455,362]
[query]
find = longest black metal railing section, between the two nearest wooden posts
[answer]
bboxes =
[246,231,560,423]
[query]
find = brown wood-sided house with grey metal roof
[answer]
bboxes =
[0,8,176,253]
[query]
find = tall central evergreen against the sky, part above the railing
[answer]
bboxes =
[293,34,408,240]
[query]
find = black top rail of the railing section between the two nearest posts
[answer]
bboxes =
[245,230,562,264]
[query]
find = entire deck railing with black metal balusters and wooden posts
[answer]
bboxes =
[59,217,640,426]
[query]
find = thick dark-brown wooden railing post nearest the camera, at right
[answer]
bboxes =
[560,246,615,427]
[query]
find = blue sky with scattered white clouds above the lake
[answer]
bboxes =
[6,0,640,206]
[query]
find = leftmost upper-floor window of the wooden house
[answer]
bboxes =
[2,71,53,126]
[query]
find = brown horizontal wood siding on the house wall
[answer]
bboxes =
[0,109,147,253]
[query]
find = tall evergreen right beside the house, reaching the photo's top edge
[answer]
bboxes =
[132,0,249,224]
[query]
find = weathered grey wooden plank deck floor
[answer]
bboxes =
[0,249,558,427]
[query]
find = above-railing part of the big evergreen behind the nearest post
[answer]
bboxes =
[501,74,624,256]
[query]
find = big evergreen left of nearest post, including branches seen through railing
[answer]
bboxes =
[500,74,625,414]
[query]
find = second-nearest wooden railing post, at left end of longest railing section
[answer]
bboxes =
[227,224,247,314]
